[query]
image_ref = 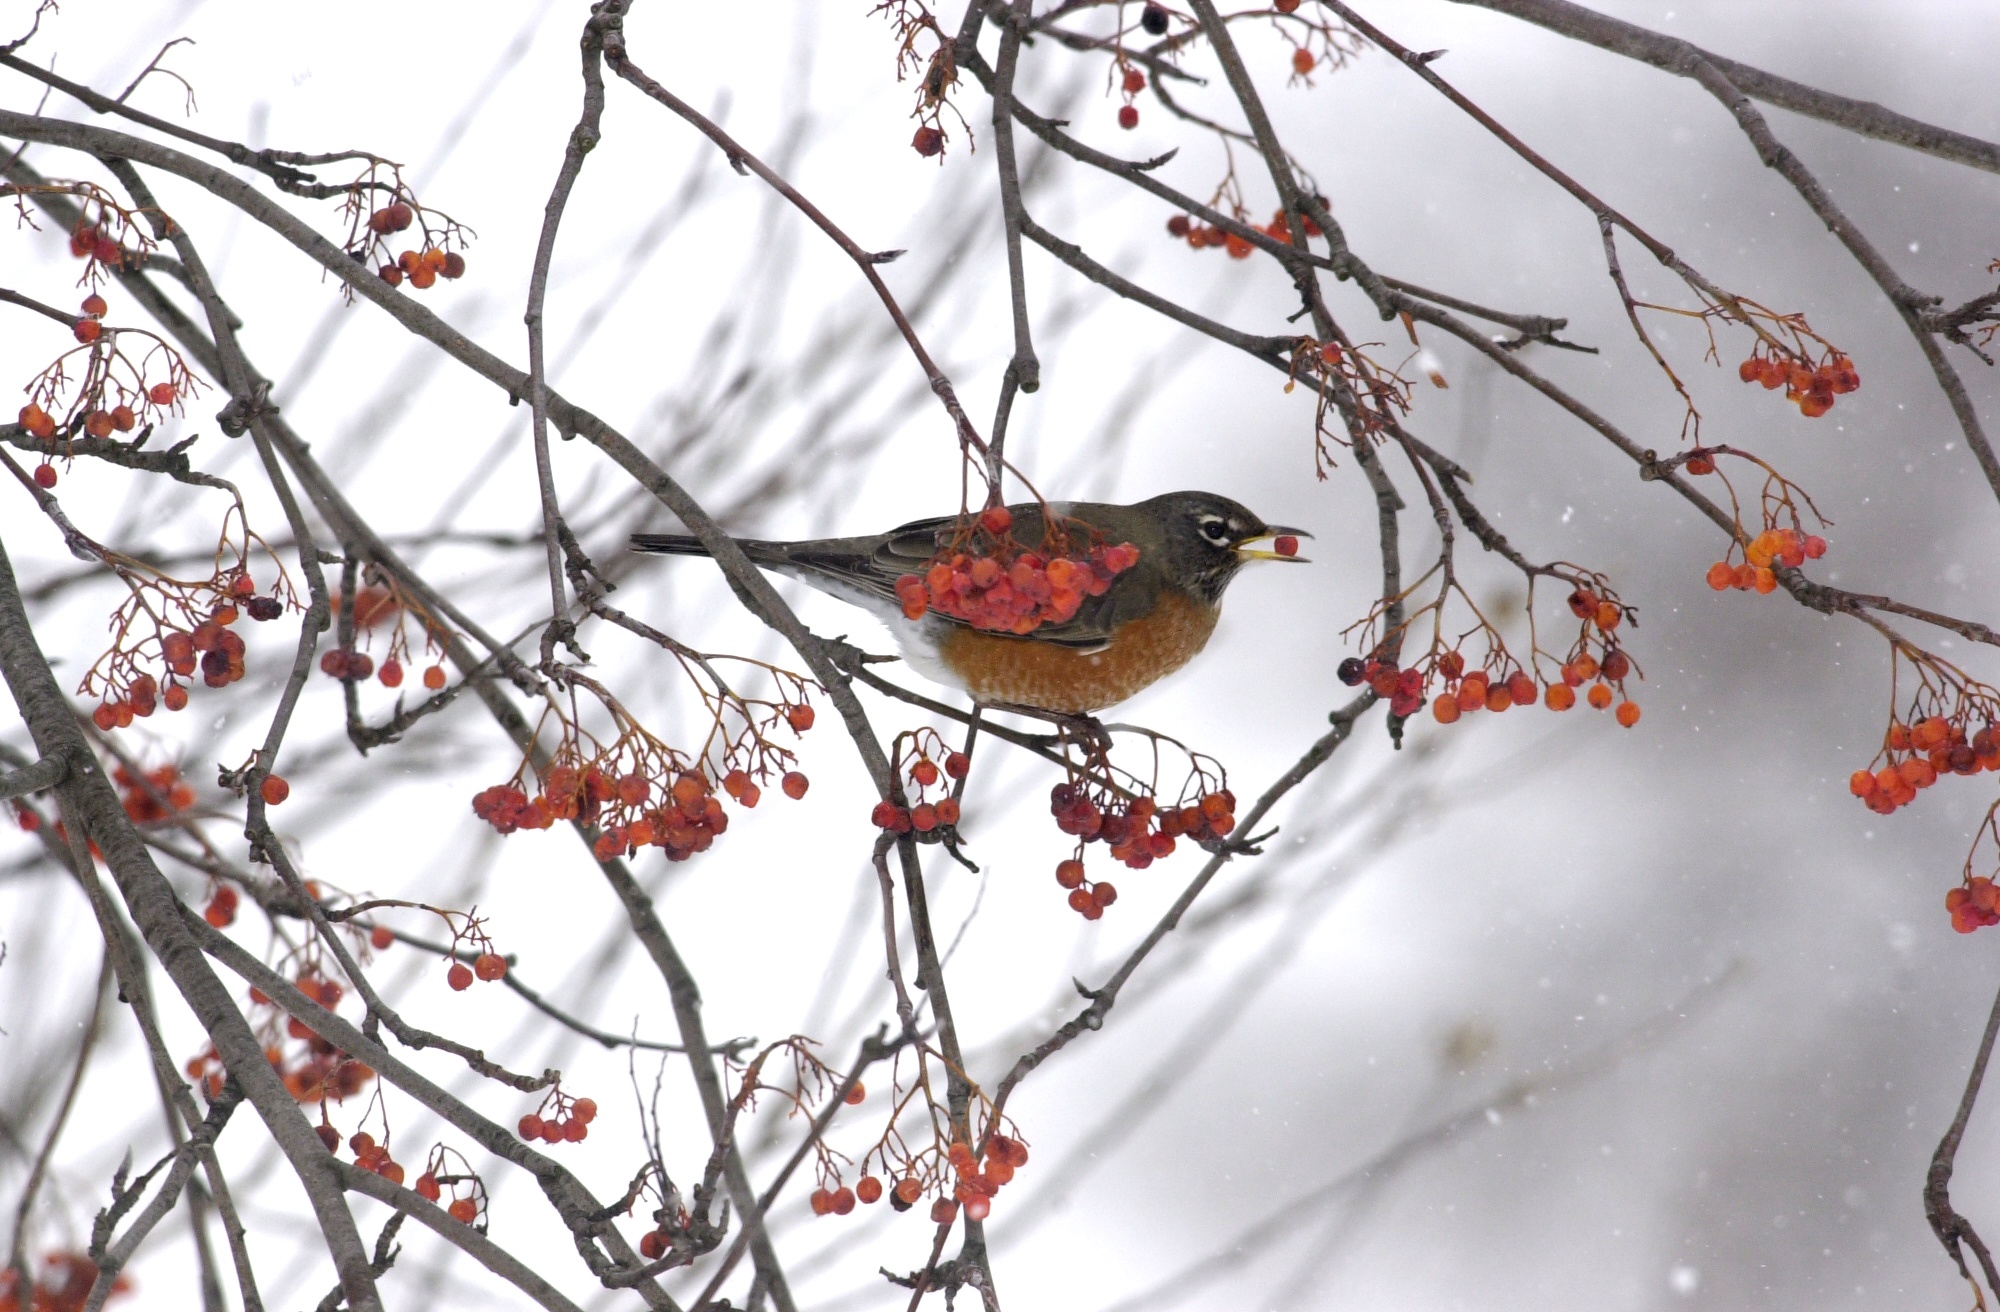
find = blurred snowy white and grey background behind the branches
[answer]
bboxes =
[0,0,2000,1310]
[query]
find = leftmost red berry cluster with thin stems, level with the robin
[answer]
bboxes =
[78,544,296,732]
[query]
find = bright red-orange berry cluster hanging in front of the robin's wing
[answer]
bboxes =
[896,506,1138,634]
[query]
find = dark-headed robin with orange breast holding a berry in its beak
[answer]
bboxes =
[632,492,1312,716]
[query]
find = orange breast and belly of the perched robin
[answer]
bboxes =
[938,592,1222,714]
